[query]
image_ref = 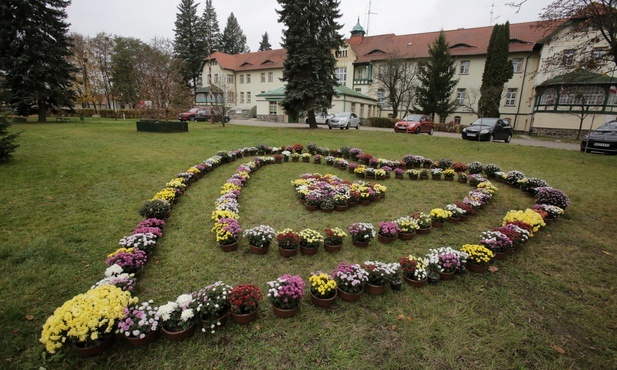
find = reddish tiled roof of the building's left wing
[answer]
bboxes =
[205,49,287,72]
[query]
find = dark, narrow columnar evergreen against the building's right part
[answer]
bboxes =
[478,22,514,117]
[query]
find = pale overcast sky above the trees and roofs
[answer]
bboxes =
[67,0,551,51]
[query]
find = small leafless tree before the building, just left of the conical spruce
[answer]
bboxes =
[376,51,417,118]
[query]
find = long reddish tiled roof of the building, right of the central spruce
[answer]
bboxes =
[348,22,562,63]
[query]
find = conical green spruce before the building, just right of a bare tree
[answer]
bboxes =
[416,31,458,119]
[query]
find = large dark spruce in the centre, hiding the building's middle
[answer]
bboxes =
[277,0,344,128]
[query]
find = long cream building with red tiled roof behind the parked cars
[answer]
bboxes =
[203,15,617,136]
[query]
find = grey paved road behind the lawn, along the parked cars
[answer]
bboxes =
[229,119,580,150]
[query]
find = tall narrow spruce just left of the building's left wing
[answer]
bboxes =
[174,0,206,92]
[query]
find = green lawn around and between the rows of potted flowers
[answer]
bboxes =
[0,119,617,369]
